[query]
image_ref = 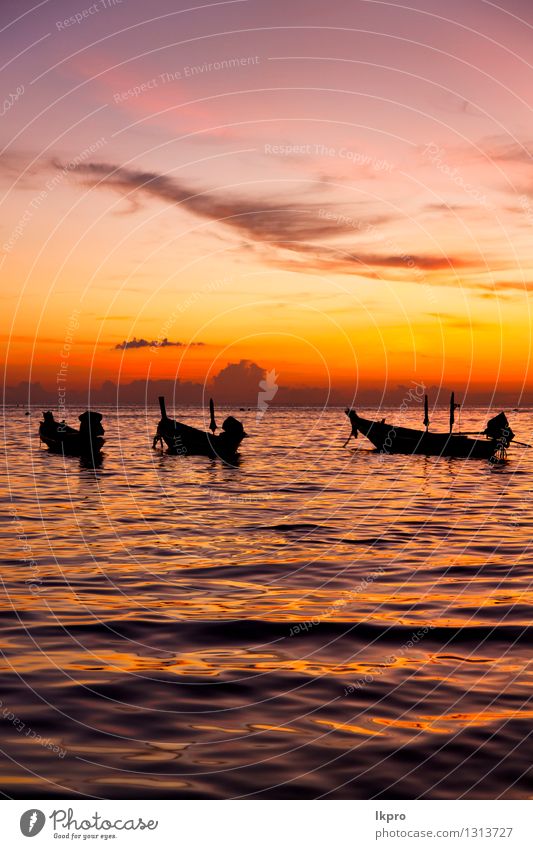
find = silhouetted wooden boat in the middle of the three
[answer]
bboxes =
[152,396,248,459]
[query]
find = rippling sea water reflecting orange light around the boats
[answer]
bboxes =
[0,409,533,798]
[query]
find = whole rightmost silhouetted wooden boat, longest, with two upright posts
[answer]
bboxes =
[345,393,514,462]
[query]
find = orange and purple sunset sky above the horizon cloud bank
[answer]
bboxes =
[0,0,533,397]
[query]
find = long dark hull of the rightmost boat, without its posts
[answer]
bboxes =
[351,416,499,460]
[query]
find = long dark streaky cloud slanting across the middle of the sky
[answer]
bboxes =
[57,163,490,278]
